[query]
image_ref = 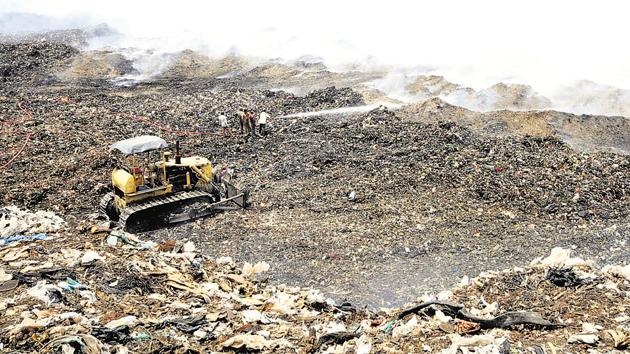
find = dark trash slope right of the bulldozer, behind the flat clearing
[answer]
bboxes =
[198,108,630,220]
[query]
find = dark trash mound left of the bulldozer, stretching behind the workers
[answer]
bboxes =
[0,87,363,211]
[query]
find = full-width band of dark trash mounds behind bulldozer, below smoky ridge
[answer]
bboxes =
[0,96,630,219]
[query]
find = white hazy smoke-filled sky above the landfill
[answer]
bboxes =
[0,0,630,93]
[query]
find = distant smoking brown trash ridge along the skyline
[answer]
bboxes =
[0,37,630,154]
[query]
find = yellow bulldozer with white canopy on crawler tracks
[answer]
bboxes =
[100,135,249,232]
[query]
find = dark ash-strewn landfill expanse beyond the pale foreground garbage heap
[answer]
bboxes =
[0,41,630,306]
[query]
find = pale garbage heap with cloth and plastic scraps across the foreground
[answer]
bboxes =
[0,207,630,354]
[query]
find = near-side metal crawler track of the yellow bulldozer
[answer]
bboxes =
[118,191,212,232]
